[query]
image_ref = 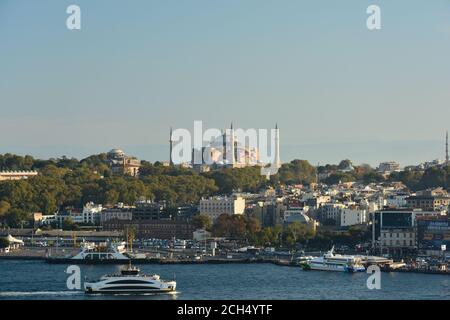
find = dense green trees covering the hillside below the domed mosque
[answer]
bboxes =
[0,153,315,227]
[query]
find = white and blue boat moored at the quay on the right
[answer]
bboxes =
[304,247,366,272]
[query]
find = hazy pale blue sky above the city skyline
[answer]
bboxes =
[0,0,450,165]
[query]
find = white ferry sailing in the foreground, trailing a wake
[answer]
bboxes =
[84,263,177,294]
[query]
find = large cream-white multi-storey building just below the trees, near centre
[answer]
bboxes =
[199,196,245,221]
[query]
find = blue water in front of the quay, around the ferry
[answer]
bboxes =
[0,260,450,300]
